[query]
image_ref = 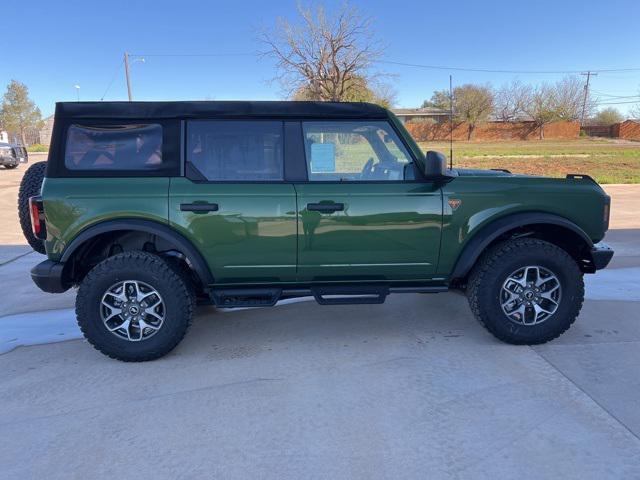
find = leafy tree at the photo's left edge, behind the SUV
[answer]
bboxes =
[0,80,43,145]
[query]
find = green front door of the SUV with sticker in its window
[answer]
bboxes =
[296,121,442,282]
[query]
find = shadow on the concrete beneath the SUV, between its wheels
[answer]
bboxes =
[175,294,499,359]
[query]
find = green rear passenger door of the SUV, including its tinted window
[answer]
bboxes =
[169,120,297,284]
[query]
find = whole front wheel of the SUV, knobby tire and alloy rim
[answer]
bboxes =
[467,238,584,345]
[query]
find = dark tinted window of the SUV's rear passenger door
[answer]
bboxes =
[187,120,284,182]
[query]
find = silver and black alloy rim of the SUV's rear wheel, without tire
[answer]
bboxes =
[100,280,166,342]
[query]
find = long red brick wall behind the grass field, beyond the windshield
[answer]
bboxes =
[405,122,580,142]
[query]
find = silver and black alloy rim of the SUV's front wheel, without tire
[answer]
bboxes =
[500,265,562,325]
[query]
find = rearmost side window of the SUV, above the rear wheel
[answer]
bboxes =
[64,124,166,171]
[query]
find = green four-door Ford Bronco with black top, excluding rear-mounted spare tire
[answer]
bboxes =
[29,102,613,361]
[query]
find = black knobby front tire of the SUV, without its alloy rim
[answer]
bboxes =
[467,238,584,345]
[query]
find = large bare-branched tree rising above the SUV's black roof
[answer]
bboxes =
[261,4,382,101]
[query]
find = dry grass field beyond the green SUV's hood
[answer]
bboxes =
[420,139,640,183]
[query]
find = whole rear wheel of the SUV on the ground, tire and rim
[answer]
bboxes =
[76,251,195,362]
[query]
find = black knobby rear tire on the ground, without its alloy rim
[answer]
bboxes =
[76,251,195,362]
